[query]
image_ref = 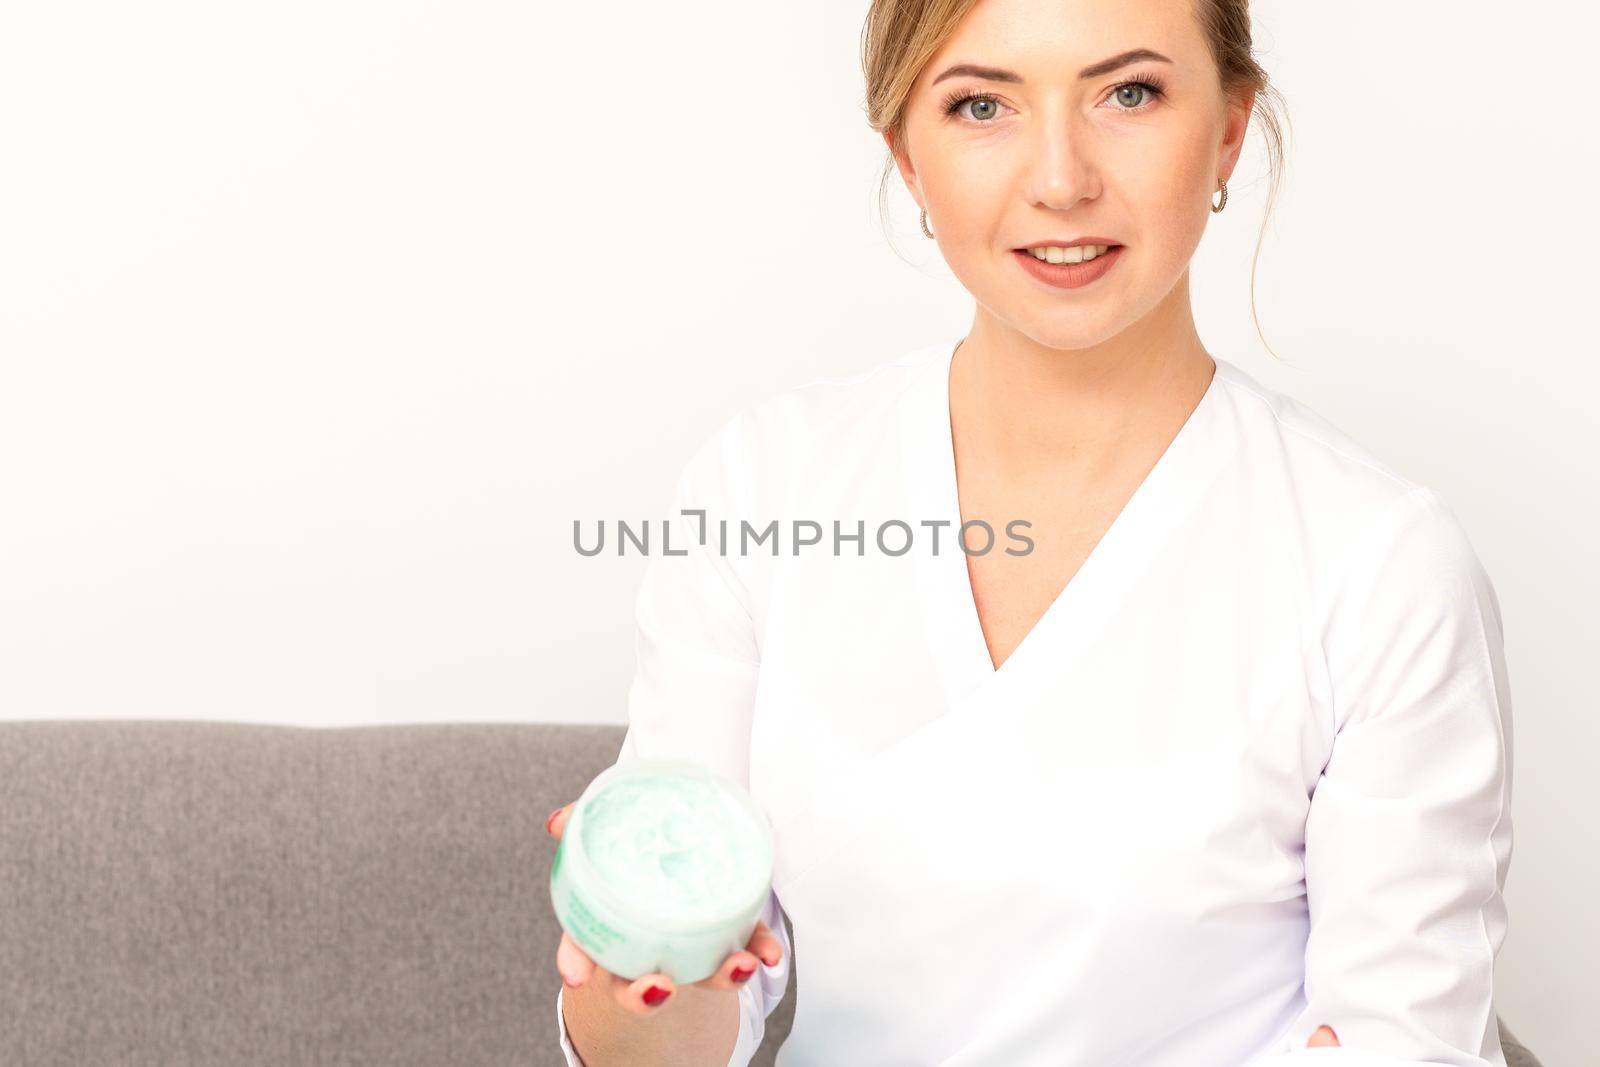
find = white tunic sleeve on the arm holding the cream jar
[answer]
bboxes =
[555,413,790,1067]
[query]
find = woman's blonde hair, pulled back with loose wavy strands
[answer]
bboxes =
[861,0,1288,355]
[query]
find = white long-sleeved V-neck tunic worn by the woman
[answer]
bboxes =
[557,338,1512,1067]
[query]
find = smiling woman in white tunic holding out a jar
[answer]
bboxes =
[552,0,1512,1067]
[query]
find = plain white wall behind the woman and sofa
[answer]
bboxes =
[0,0,1600,1065]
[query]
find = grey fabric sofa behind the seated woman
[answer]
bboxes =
[0,720,1538,1067]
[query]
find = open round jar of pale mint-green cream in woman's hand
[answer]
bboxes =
[550,760,773,985]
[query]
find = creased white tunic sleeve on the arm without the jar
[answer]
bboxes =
[1253,486,1512,1067]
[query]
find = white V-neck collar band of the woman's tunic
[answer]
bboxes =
[896,338,1232,710]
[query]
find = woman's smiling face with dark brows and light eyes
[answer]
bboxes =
[890,0,1254,349]
